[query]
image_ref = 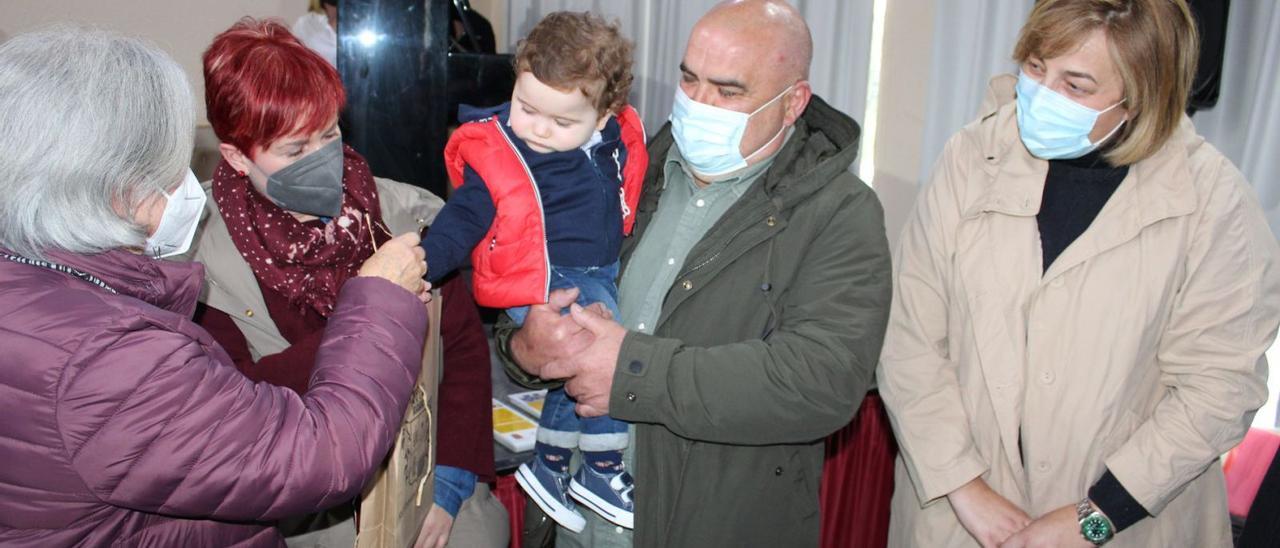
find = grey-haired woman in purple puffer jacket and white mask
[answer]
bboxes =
[0,28,426,547]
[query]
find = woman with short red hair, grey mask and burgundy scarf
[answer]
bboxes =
[195,18,507,545]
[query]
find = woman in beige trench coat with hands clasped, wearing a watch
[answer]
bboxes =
[878,0,1280,548]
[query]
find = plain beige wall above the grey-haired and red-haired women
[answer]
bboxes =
[0,0,307,124]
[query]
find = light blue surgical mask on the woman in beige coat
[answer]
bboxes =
[1018,73,1124,160]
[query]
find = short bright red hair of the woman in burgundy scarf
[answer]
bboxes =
[204,17,347,159]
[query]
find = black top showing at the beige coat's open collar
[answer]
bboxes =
[1036,150,1129,271]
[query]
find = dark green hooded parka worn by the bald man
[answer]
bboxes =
[498,96,891,547]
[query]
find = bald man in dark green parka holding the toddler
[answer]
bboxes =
[498,0,890,547]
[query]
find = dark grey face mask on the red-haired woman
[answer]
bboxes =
[266,138,342,218]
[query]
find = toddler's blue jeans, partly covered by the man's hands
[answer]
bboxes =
[507,261,627,452]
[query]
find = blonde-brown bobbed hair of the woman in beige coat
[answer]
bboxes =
[1014,0,1199,165]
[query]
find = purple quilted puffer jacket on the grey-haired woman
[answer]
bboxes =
[0,251,426,547]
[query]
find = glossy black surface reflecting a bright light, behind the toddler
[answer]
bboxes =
[338,0,515,196]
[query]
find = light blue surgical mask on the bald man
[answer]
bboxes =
[671,85,795,178]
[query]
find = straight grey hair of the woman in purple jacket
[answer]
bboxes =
[0,26,195,257]
